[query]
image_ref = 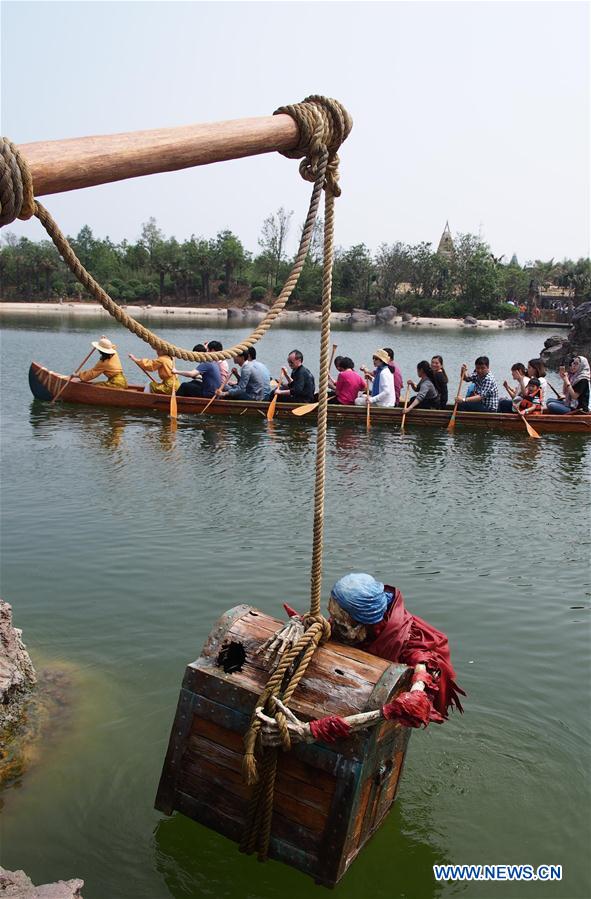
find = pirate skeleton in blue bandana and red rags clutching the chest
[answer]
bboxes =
[257,573,466,745]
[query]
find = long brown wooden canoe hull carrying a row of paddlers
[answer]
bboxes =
[29,362,591,436]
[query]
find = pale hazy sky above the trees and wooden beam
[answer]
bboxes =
[2,0,590,263]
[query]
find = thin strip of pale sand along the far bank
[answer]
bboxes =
[0,302,506,329]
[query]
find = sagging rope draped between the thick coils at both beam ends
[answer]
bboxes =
[0,95,352,362]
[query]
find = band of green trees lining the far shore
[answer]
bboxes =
[0,217,591,318]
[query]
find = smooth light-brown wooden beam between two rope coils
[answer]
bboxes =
[19,115,299,197]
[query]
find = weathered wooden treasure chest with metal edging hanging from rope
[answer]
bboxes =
[156,605,411,886]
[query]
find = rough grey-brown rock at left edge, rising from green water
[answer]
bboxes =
[0,599,36,748]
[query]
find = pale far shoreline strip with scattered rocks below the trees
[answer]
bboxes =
[0,302,523,329]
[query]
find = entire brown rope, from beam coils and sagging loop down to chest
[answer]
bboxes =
[0,95,352,860]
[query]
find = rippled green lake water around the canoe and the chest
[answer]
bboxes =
[0,318,591,899]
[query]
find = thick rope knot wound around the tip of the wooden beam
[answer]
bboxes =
[273,94,353,197]
